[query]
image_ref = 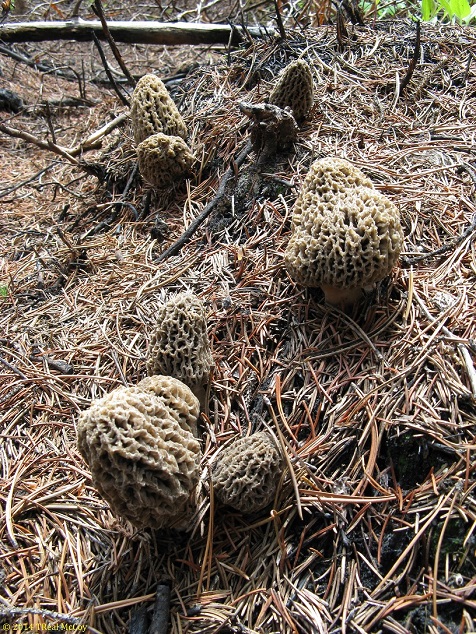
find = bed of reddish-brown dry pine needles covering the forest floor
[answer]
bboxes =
[0,3,476,634]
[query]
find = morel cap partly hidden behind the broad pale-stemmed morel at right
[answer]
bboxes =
[292,156,373,227]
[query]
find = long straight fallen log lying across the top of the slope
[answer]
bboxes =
[0,19,276,46]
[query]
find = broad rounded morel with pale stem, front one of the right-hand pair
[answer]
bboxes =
[285,187,403,304]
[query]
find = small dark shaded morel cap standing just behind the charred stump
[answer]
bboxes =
[269,59,314,122]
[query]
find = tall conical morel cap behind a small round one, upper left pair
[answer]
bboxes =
[131,74,187,143]
